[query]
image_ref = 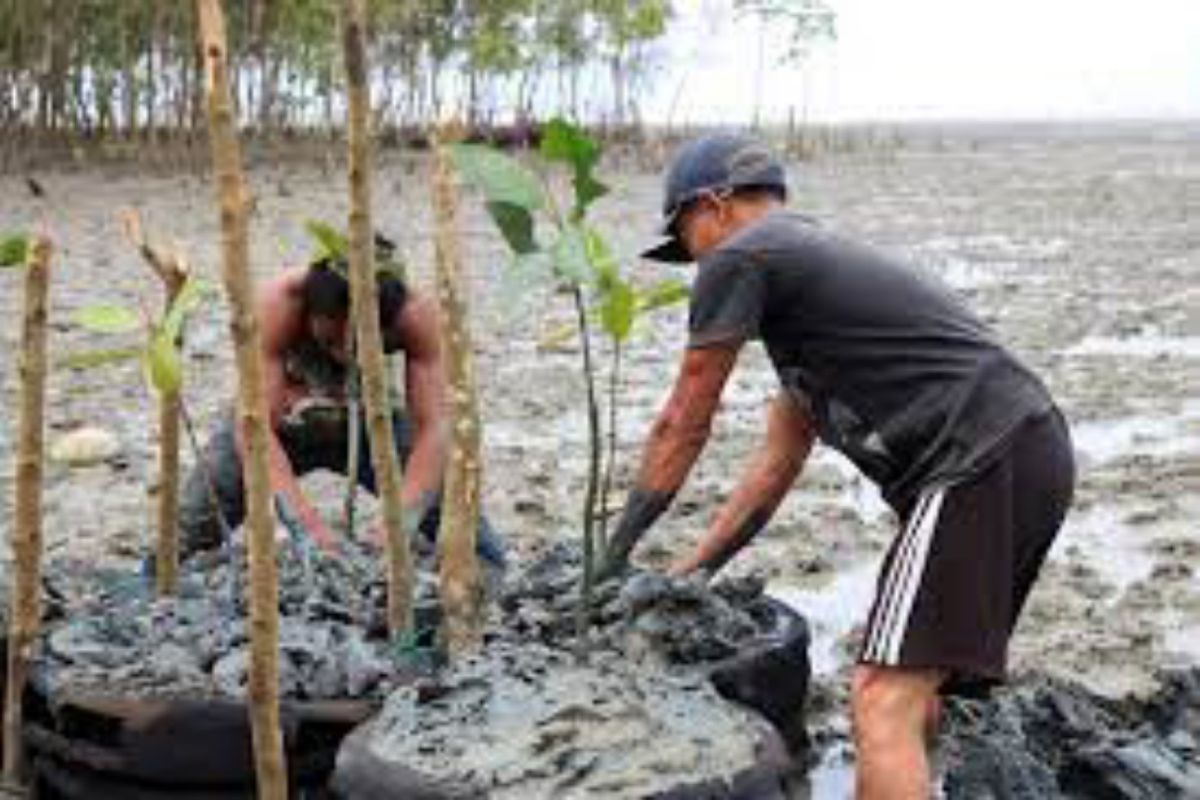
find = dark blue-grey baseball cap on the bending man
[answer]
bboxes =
[642,133,787,264]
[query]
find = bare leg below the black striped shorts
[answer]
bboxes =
[851,664,944,800]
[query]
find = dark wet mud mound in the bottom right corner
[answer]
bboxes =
[942,669,1200,800]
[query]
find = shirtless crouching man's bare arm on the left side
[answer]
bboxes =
[234,270,337,551]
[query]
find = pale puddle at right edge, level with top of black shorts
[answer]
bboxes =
[1070,408,1200,467]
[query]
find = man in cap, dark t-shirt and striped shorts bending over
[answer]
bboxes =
[602,134,1075,800]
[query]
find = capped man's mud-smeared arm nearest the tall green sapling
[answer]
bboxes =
[601,342,740,576]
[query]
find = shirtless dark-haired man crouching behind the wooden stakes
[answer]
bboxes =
[180,239,504,566]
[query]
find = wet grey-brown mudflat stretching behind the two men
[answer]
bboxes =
[0,120,1200,782]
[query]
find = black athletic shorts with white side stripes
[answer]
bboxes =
[858,409,1075,693]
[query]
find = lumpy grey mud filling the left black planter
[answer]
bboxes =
[37,546,451,700]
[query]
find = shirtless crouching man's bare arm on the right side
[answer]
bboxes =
[396,296,448,513]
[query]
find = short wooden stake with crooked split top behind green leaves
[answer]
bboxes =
[121,209,188,597]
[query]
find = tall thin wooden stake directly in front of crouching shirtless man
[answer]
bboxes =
[342,0,413,637]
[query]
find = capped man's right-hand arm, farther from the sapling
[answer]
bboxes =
[671,391,816,575]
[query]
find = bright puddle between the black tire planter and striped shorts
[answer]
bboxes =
[767,559,878,676]
